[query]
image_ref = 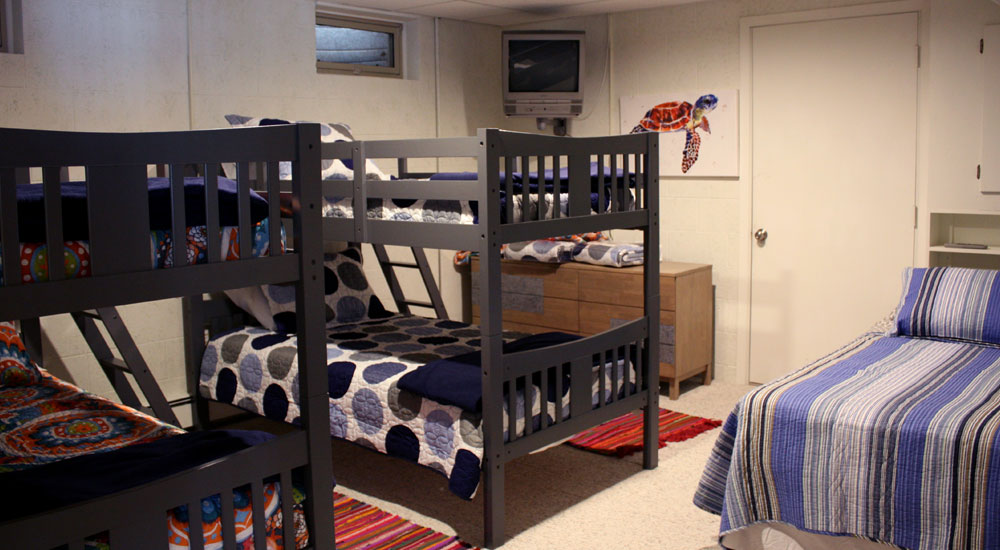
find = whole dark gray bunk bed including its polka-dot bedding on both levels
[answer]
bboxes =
[193,129,659,547]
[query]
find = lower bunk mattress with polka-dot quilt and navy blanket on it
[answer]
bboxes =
[200,315,636,499]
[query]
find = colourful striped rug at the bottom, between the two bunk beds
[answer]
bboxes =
[333,491,473,550]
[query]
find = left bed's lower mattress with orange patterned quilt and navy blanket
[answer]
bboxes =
[0,369,308,550]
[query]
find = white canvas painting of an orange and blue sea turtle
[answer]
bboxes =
[620,90,739,177]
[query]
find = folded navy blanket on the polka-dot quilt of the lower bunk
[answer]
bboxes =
[399,332,581,413]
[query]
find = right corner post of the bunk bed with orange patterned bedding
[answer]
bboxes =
[292,124,338,550]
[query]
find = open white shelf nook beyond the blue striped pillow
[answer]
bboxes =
[928,211,1000,269]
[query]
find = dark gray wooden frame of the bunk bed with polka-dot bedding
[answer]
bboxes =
[195,129,659,547]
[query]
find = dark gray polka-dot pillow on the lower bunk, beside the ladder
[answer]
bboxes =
[263,247,391,333]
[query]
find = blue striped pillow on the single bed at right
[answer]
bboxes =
[896,267,1000,344]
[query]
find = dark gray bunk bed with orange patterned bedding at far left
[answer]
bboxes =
[0,125,334,549]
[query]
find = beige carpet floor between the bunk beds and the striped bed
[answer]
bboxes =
[333,382,751,550]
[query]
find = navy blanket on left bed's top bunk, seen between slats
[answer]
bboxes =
[17,178,267,243]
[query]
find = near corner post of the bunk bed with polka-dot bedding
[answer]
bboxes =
[478,129,504,548]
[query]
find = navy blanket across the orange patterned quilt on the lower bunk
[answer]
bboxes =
[0,430,274,519]
